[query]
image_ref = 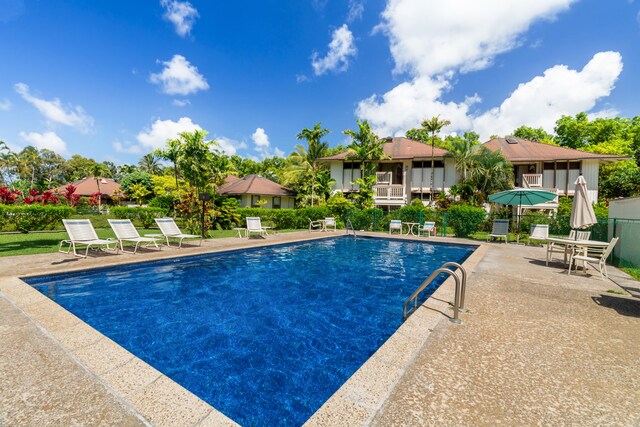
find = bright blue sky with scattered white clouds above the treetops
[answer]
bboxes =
[0,0,640,164]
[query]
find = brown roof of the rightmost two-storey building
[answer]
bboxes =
[484,137,626,162]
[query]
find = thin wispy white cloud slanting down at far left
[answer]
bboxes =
[13,83,93,133]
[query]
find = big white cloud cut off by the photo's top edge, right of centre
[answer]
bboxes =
[381,0,576,76]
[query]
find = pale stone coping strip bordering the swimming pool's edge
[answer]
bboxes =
[0,233,486,426]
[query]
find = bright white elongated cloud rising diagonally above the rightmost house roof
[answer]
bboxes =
[473,52,622,138]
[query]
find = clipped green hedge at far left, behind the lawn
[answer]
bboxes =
[0,205,75,233]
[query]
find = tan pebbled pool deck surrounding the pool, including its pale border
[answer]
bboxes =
[0,232,640,426]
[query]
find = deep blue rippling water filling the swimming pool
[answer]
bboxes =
[25,237,475,426]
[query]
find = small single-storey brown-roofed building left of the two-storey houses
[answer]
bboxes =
[218,175,296,209]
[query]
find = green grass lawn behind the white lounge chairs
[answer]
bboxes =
[0,228,296,257]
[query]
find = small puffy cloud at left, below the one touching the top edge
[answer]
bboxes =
[149,55,209,96]
